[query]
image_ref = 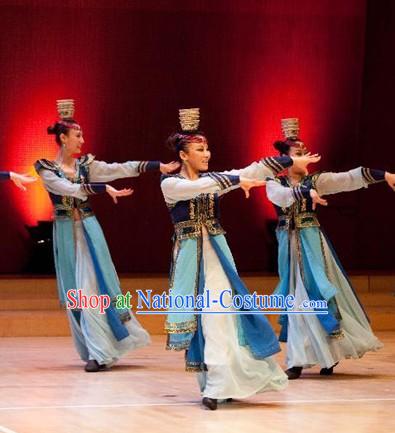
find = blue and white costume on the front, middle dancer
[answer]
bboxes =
[161,157,292,399]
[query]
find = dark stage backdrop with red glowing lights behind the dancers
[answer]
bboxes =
[0,0,395,273]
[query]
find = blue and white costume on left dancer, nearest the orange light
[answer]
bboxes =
[35,155,160,366]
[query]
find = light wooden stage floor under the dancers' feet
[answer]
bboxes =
[0,332,395,433]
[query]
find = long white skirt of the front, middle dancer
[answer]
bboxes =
[198,237,288,399]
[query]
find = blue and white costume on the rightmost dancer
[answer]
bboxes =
[266,167,384,368]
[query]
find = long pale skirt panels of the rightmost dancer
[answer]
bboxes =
[286,232,383,368]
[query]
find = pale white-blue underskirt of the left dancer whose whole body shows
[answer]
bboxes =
[67,221,150,366]
